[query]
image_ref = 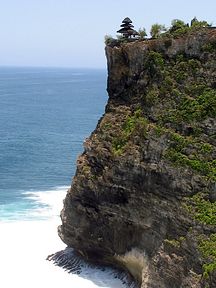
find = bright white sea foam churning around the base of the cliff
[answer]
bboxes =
[0,187,132,288]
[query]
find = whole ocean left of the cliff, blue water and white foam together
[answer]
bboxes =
[0,67,128,288]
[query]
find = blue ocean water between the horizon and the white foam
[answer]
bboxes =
[0,67,107,220]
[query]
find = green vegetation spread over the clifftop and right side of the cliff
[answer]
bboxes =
[104,19,216,282]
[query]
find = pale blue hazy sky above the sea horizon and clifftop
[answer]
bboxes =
[0,0,216,68]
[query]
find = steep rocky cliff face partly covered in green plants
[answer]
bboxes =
[59,28,216,288]
